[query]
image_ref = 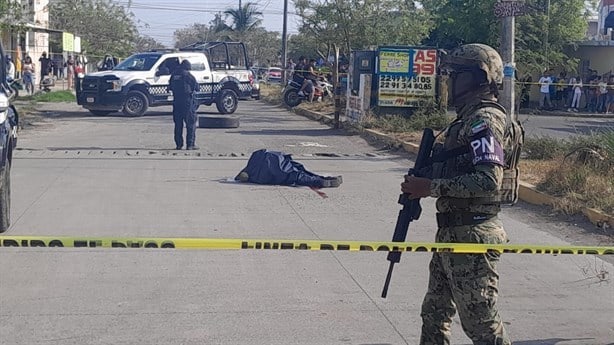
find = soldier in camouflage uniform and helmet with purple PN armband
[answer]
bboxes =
[401,44,511,345]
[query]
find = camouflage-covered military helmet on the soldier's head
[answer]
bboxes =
[442,43,503,84]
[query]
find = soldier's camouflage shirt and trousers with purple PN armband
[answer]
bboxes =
[420,45,511,345]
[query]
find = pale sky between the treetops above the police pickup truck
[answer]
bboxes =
[115,0,297,47]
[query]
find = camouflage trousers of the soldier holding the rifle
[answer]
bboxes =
[420,218,512,345]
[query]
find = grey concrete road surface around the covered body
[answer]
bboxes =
[0,101,614,345]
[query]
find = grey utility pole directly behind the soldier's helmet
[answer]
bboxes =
[499,12,516,119]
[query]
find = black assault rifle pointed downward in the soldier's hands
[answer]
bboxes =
[382,128,435,298]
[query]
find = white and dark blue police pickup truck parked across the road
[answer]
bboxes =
[76,42,254,116]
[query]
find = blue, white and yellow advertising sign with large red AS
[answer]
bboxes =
[377,48,437,107]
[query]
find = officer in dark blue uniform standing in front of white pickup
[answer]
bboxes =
[169,60,199,150]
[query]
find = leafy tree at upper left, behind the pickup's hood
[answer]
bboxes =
[49,0,139,57]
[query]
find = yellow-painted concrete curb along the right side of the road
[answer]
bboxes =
[293,108,614,228]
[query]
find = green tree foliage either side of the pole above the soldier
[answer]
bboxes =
[422,0,589,75]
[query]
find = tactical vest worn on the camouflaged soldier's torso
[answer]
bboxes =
[430,101,524,205]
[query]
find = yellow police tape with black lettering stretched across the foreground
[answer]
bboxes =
[0,236,614,255]
